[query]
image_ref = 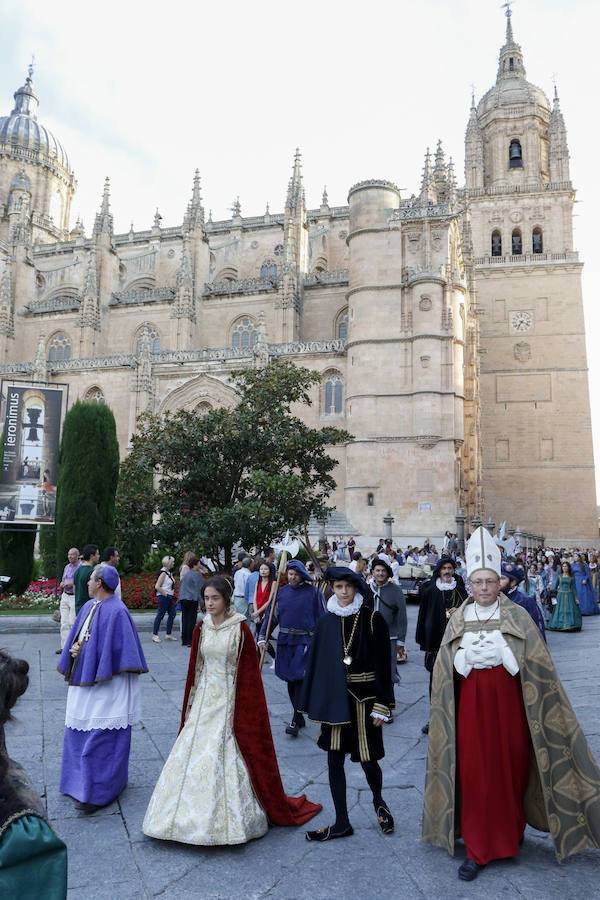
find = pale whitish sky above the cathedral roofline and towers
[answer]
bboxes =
[0,0,600,485]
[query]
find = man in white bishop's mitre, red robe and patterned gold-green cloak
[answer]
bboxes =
[423,528,600,881]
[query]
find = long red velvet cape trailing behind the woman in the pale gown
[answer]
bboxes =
[179,622,322,825]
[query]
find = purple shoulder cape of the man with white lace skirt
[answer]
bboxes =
[58,594,148,687]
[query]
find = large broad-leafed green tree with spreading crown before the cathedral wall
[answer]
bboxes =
[120,362,352,568]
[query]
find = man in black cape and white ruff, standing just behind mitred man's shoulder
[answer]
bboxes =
[416,556,467,734]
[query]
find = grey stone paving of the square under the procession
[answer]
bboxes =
[0,607,600,900]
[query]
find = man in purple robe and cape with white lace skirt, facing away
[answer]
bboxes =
[58,564,148,812]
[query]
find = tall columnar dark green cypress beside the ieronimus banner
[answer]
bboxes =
[56,401,119,565]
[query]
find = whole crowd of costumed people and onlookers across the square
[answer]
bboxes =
[0,528,600,881]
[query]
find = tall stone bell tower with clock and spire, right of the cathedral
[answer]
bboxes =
[472,9,598,546]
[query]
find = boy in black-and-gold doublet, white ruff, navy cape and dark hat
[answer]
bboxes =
[300,566,394,841]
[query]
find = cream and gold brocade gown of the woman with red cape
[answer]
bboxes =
[143,613,268,845]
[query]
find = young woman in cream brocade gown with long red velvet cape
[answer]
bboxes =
[143,576,320,846]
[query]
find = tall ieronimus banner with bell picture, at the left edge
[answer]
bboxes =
[0,381,66,525]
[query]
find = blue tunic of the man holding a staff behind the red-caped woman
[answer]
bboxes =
[261,581,326,681]
